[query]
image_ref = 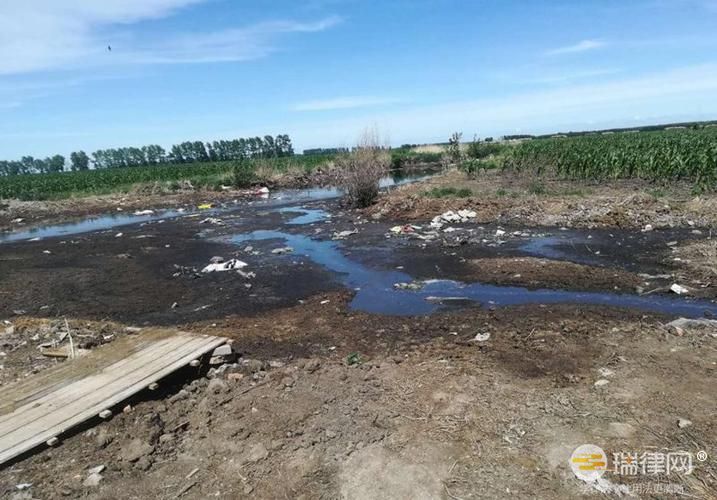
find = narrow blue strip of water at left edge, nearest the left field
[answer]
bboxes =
[0,210,183,243]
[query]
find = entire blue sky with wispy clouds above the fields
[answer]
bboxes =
[0,0,717,159]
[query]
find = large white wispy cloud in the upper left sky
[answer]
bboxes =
[0,0,340,75]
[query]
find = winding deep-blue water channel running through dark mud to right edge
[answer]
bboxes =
[231,230,717,318]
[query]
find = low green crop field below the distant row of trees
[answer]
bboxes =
[0,155,333,200]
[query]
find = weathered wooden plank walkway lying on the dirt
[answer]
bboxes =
[0,330,226,464]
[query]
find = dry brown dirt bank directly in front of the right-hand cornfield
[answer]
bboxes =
[368,171,717,229]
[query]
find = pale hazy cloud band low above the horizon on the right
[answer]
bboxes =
[269,64,717,147]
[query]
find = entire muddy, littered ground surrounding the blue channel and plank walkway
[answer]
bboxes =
[0,173,717,499]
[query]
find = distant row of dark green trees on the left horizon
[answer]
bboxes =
[0,134,294,175]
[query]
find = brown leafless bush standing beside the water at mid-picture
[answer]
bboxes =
[335,130,391,207]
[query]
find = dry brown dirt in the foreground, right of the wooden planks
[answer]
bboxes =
[0,295,717,499]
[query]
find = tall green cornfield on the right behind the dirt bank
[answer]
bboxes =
[504,127,717,190]
